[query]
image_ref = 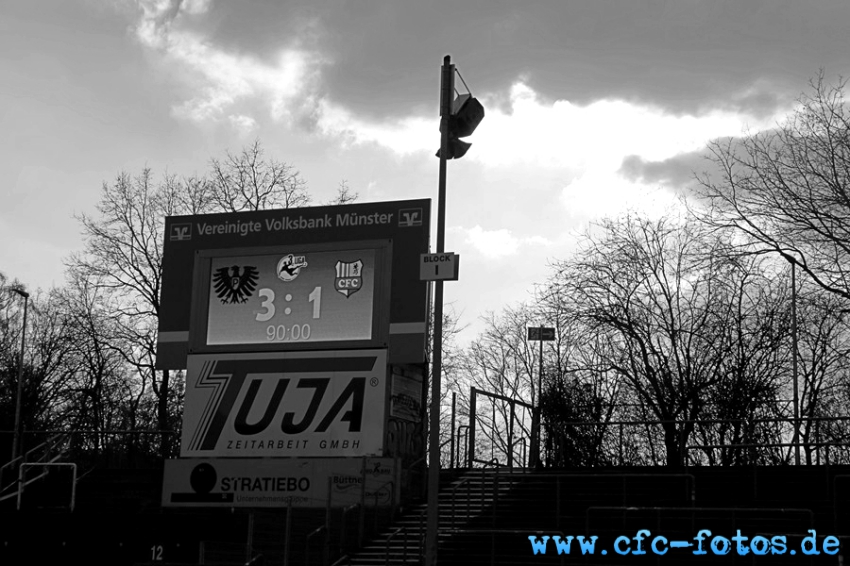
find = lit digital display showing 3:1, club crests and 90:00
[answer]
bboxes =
[199,247,381,349]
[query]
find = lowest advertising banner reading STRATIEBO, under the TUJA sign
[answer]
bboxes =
[162,458,398,507]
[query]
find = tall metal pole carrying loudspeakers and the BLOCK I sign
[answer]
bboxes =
[425,55,454,566]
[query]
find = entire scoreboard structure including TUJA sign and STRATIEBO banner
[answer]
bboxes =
[156,199,430,496]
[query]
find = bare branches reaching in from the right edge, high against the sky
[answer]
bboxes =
[697,73,850,308]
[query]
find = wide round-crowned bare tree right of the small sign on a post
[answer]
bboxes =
[549,216,788,466]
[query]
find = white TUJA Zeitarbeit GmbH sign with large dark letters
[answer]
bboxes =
[180,350,387,457]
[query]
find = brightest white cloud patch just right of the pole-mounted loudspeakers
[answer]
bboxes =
[469,83,788,169]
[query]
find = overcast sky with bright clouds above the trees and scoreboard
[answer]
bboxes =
[0,0,850,344]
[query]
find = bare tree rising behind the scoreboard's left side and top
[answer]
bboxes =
[68,141,310,462]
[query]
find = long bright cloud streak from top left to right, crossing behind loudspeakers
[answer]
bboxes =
[126,0,796,194]
